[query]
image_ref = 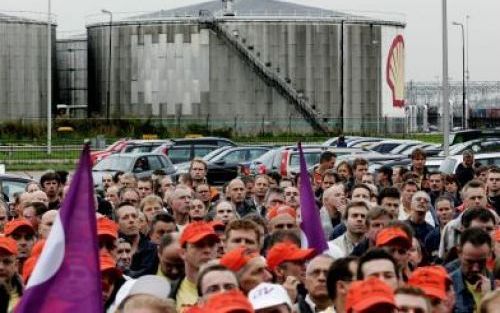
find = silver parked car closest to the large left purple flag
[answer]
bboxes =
[92,153,176,187]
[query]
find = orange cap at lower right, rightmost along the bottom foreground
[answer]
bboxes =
[408,266,450,300]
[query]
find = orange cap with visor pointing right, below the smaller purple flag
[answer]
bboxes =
[267,241,315,270]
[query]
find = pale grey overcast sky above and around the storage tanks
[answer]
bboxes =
[0,0,500,81]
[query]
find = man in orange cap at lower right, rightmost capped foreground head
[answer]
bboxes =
[408,266,455,313]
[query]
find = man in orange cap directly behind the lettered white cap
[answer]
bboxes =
[220,247,272,294]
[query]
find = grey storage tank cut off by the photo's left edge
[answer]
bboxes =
[0,13,56,120]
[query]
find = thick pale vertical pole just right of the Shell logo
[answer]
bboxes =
[442,0,450,157]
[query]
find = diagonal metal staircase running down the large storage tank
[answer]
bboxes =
[200,11,330,134]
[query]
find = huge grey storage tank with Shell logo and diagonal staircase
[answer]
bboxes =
[87,0,405,132]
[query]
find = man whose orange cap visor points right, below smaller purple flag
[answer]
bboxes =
[267,241,314,284]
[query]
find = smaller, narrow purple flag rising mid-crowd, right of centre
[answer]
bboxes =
[298,142,328,254]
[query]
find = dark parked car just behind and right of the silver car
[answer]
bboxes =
[153,137,236,164]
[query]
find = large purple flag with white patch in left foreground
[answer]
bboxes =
[15,145,103,313]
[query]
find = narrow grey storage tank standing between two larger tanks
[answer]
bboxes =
[56,34,88,118]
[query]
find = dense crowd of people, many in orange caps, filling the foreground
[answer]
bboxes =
[0,149,500,313]
